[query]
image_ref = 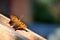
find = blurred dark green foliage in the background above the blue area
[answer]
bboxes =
[33,0,60,23]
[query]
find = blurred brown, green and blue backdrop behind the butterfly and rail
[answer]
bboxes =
[0,0,60,38]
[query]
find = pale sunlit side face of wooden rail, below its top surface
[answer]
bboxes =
[0,24,28,40]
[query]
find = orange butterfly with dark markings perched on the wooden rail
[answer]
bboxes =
[9,15,28,32]
